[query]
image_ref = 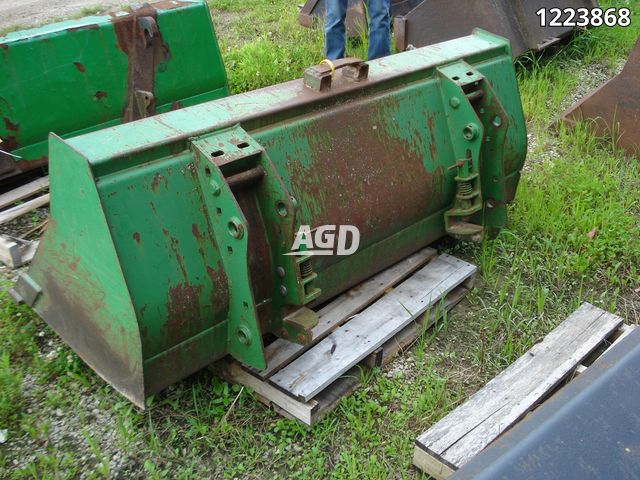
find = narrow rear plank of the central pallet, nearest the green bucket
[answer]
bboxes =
[254,248,437,379]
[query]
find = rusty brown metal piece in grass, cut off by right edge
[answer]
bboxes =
[562,38,640,157]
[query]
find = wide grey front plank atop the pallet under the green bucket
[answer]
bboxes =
[270,255,476,401]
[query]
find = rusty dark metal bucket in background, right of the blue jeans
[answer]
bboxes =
[394,0,597,56]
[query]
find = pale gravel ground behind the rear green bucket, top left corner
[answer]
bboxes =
[0,0,126,28]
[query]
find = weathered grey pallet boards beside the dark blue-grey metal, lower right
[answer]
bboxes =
[413,303,632,480]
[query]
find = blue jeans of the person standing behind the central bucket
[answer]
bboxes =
[324,0,391,60]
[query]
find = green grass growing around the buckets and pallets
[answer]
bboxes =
[0,0,640,479]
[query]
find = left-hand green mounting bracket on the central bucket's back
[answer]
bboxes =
[192,126,320,368]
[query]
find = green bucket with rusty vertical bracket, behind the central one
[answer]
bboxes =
[0,0,229,178]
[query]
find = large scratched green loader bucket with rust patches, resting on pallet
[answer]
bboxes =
[13,31,526,405]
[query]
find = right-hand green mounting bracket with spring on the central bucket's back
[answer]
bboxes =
[437,61,508,241]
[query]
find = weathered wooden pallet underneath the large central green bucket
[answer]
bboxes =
[212,248,476,426]
